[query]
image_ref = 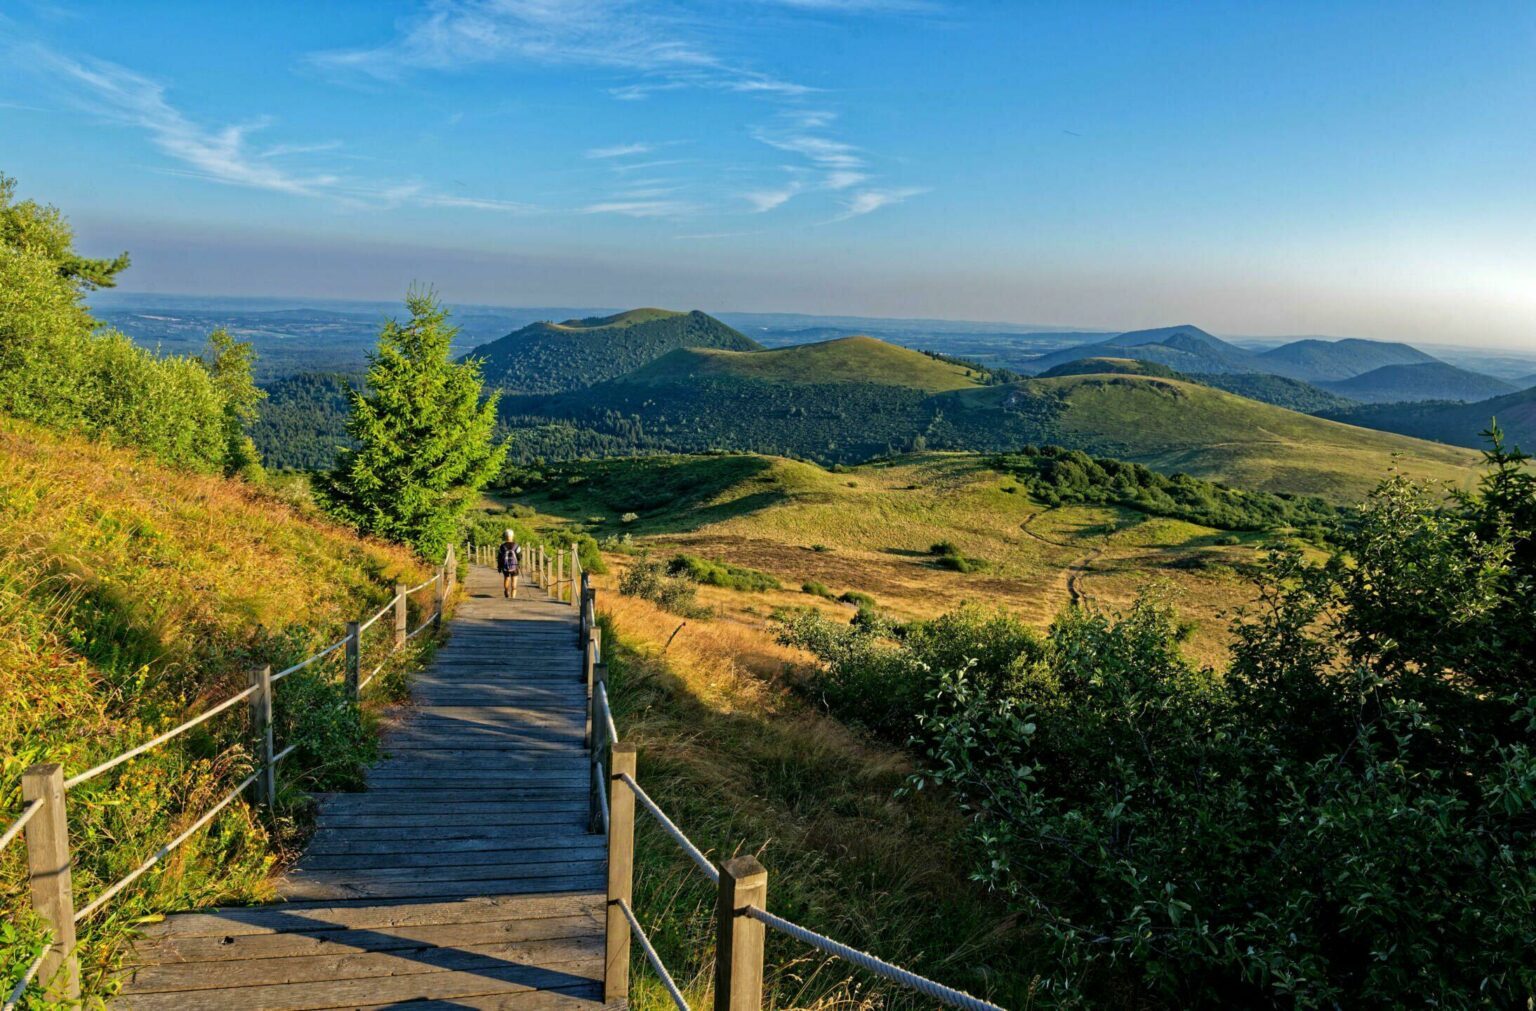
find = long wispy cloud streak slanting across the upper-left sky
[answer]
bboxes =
[22,45,531,212]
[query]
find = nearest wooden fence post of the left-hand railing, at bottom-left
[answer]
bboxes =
[22,762,80,1003]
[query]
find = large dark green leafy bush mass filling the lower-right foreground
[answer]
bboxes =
[785,446,1536,1008]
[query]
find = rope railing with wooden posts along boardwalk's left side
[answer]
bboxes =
[0,547,456,1011]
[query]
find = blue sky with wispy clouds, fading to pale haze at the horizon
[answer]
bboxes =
[0,0,1536,347]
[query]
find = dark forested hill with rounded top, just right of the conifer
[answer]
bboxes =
[468,309,762,393]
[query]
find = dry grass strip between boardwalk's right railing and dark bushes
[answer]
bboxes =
[598,574,1028,1011]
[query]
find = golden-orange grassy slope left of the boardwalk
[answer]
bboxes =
[0,419,429,991]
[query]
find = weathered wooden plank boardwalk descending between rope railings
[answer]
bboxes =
[112,567,617,1011]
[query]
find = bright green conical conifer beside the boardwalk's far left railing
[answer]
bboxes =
[319,289,507,558]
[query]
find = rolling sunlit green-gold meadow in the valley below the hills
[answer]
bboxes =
[503,453,1296,659]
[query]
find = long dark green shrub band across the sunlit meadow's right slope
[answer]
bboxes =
[988,446,1342,539]
